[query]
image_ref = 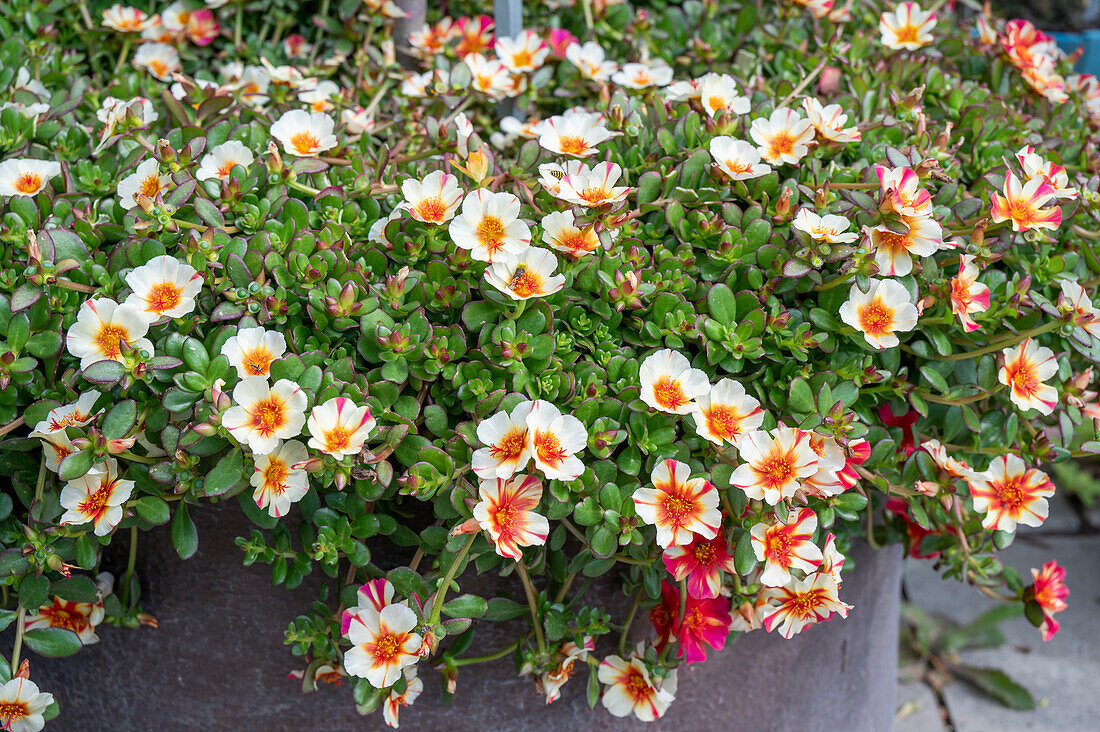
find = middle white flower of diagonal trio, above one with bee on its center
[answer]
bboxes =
[448,188,531,262]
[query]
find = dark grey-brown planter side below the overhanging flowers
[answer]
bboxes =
[25,502,902,732]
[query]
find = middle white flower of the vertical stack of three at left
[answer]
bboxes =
[221,376,309,455]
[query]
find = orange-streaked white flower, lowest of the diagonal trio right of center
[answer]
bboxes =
[729,426,817,505]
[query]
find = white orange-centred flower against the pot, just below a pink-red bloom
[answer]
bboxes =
[344,604,422,689]
